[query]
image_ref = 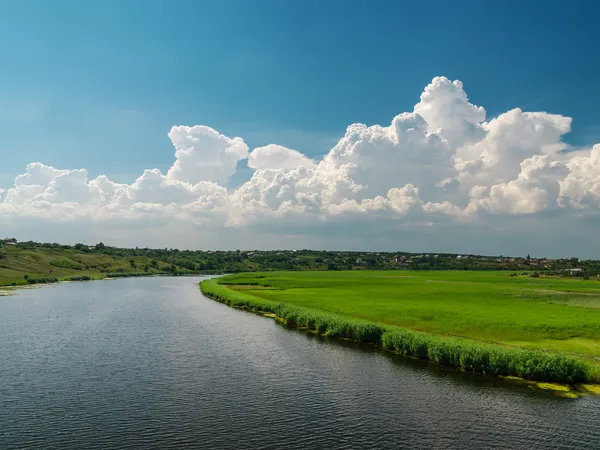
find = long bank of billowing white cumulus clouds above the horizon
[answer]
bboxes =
[0,77,600,254]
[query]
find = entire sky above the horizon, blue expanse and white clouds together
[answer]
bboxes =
[0,0,600,255]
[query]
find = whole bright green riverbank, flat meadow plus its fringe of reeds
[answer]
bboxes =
[202,271,600,384]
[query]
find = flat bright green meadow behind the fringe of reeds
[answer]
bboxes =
[207,271,600,361]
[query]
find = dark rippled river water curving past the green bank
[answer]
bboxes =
[0,278,600,450]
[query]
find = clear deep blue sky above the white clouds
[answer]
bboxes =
[0,0,600,181]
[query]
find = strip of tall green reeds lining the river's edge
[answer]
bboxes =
[200,279,600,384]
